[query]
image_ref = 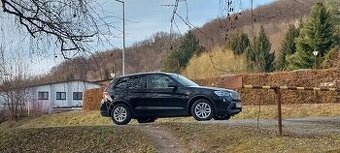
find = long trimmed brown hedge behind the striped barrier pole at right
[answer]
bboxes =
[197,69,340,105]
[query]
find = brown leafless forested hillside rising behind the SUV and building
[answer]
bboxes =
[39,0,312,82]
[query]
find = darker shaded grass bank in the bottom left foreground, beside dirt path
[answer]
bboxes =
[0,126,155,152]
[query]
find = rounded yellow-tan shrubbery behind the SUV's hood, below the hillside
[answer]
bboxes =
[182,47,246,79]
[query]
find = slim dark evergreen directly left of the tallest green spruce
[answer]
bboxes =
[276,25,299,70]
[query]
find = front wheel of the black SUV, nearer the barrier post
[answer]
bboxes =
[191,99,214,121]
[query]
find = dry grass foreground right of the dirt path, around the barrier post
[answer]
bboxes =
[160,123,340,153]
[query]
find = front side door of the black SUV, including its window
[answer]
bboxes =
[147,74,186,116]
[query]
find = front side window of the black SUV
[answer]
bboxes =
[148,75,174,89]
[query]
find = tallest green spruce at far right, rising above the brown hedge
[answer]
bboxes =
[288,3,335,69]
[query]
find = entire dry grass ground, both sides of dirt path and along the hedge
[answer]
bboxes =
[0,104,340,152]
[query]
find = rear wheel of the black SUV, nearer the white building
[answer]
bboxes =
[111,104,131,125]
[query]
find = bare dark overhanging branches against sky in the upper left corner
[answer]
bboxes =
[1,0,117,58]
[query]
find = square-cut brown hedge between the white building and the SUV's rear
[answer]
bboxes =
[83,88,104,111]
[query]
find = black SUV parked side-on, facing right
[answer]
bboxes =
[100,72,242,125]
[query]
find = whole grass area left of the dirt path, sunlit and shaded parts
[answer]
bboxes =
[0,111,156,152]
